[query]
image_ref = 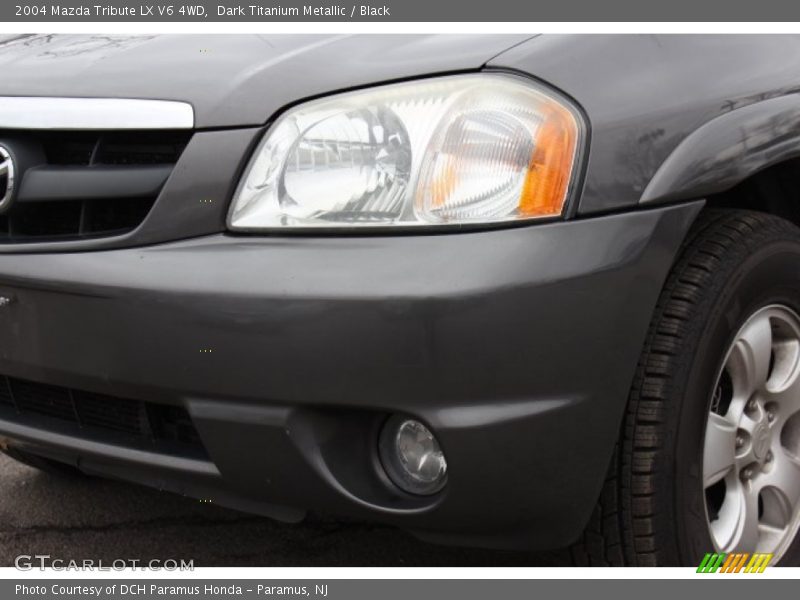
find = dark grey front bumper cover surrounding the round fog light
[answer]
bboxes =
[0,202,701,548]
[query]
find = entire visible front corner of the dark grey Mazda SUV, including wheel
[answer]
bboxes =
[0,35,800,565]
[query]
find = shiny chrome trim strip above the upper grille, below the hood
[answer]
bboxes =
[0,96,194,130]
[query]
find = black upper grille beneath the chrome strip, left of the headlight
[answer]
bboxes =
[0,130,191,244]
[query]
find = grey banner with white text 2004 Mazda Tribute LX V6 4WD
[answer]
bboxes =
[0,0,800,23]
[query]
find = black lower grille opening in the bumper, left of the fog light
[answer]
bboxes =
[0,376,207,458]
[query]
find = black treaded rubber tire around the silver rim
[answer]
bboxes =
[571,210,800,567]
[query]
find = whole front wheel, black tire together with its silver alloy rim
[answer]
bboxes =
[572,210,800,566]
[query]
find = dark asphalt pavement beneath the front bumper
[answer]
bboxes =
[0,455,568,567]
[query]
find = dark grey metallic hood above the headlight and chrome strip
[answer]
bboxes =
[0,35,530,128]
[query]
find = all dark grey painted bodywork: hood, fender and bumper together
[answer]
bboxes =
[0,36,800,547]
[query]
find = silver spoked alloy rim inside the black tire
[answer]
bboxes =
[703,305,800,560]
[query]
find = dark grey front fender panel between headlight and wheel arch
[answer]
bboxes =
[489,35,800,215]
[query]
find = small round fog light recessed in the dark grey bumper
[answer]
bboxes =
[379,416,447,496]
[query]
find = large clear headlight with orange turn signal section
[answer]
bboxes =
[228,74,582,230]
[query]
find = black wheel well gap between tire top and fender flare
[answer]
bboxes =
[707,158,800,226]
